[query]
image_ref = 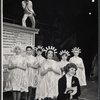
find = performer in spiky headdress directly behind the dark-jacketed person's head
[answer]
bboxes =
[58,50,70,76]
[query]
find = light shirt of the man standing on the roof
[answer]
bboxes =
[22,0,34,14]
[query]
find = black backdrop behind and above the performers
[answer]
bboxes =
[3,0,98,78]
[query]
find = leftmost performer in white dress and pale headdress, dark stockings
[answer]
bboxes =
[5,42,28,100]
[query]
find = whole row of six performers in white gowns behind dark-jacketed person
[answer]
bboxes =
[4,42,86,100]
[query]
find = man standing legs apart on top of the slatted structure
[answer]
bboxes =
[22,0,36,28]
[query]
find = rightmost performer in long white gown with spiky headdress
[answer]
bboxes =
[69,47,86,86]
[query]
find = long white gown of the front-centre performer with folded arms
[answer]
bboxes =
[39,59,60,99]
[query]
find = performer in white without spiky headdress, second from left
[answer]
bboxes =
[26,45,38,100]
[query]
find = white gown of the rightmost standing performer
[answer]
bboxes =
[69,56,86,86]
